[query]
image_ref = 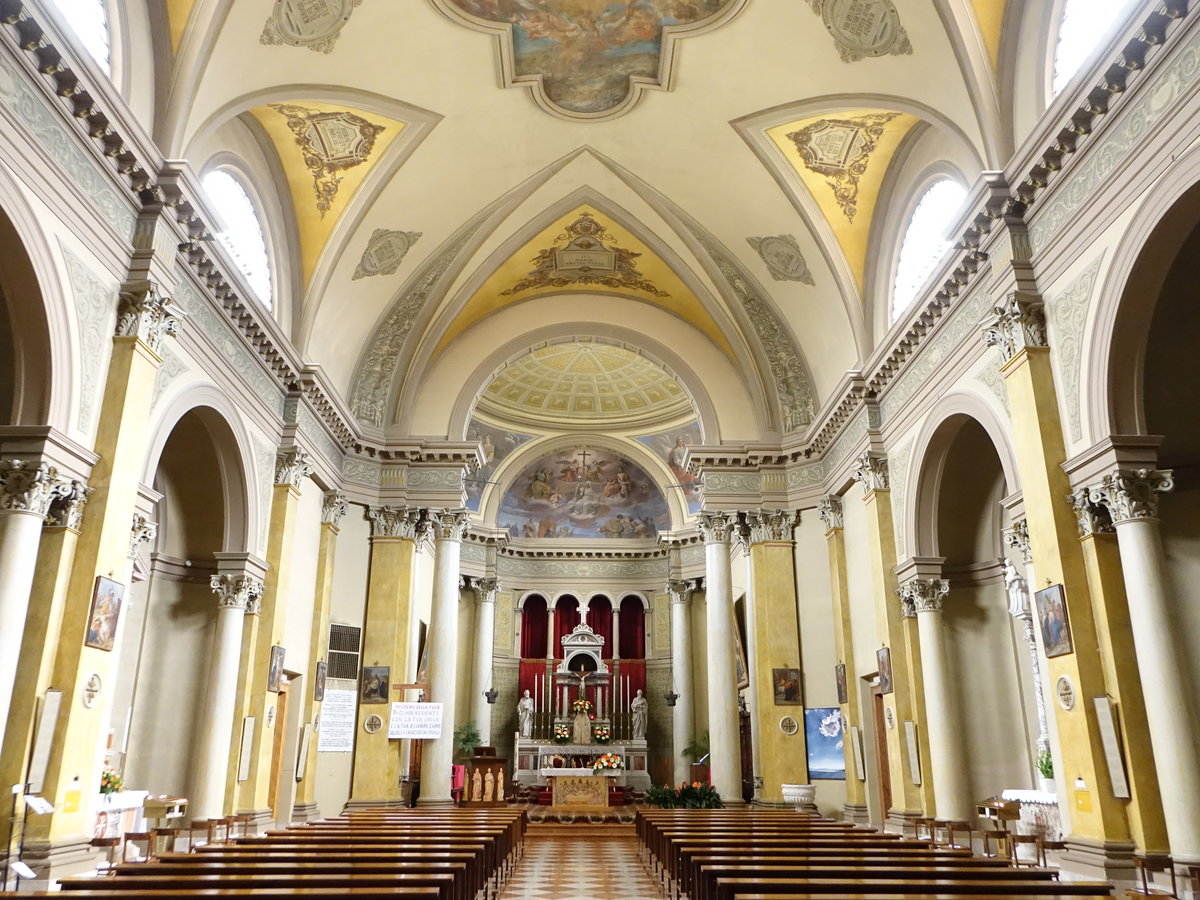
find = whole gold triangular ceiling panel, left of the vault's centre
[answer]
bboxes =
[250,100,404,284]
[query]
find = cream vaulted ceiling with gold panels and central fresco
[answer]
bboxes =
[150,0,1040,440]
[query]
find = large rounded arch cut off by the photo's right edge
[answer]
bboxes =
[1081,141,1200,442]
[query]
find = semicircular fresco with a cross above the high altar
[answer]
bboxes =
[496,446,671,539]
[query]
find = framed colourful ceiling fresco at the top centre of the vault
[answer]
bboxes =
[436,0,745,119]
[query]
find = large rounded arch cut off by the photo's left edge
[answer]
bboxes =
[0,181,72,432]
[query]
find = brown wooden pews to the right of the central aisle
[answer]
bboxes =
[635,810,1112,900]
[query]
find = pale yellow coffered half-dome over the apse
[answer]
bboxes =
[478,340,695,428]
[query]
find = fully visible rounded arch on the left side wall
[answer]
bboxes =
[142,384,260,552]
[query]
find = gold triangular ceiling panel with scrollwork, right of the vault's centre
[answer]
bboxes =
[767,109,918,289]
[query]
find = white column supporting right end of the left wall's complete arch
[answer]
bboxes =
[188,574,263,818]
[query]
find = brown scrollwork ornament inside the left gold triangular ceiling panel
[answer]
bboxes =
[270,103,385,218]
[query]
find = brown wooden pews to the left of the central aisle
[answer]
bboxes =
[0,809,526,900]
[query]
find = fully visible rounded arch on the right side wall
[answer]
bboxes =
[912,392,1020,557]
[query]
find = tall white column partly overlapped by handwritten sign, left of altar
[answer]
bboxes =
[416,510,468,806]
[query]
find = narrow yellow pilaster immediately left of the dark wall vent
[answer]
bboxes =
[293,491,349,822]
